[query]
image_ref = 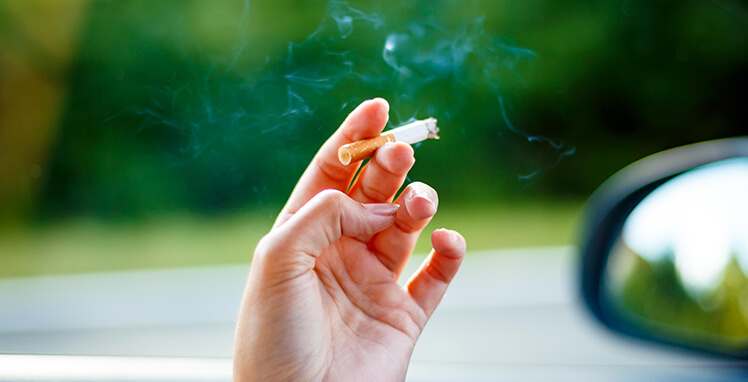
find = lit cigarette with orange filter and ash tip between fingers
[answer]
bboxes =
[338,118,439,165]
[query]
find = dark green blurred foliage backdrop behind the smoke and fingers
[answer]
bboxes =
[0,0,748,219]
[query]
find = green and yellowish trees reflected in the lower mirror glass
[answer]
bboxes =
[607,253,748,351]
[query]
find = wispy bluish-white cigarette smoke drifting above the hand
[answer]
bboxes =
[108,0,574,185]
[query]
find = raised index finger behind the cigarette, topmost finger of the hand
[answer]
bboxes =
[275,98,390,226]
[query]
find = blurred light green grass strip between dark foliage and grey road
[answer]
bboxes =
[0,203,579,278]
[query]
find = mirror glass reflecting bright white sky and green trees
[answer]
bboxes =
[601,158,748,351]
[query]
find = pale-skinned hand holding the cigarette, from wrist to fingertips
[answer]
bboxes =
[234,99,465,381]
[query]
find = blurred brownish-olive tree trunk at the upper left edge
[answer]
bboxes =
[0,0,88,222]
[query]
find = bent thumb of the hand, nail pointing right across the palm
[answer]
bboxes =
[273,190,400,257]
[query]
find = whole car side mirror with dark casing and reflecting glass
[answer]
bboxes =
[580,137,748,359]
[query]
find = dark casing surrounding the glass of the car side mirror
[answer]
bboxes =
[579,137,748,359]
